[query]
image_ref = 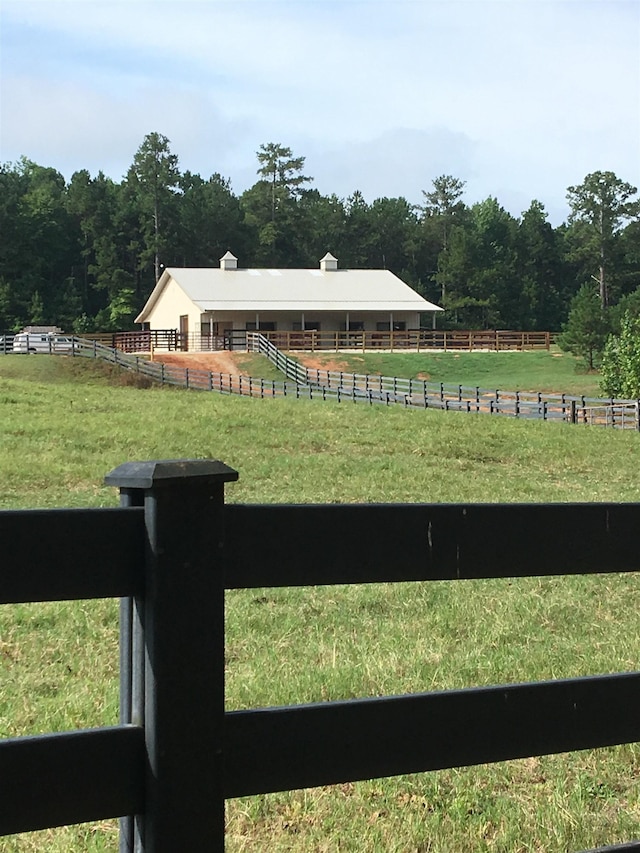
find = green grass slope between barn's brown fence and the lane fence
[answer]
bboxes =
[292,347,601,397]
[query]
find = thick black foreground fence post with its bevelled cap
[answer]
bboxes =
[105,460,238,853]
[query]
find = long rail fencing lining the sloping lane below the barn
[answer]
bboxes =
[0,332,640,430]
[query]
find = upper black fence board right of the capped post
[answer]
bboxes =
[225,504,640,589]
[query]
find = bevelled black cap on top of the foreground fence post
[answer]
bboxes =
[104,459,239,489]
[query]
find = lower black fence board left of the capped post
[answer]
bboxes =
[0,726,145,835]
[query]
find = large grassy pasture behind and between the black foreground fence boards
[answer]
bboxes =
[0,354,640,853]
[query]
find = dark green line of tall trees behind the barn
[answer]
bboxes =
[0,133,640,336]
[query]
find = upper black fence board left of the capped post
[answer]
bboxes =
[0,508,145,604]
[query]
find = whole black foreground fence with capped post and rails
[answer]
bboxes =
[0,460,640,853]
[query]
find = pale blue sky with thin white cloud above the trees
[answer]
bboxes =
[0,0,640,225]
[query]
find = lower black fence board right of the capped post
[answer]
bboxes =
[225,673,640,797]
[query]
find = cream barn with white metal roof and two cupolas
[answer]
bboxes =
[136,252,442,338]
